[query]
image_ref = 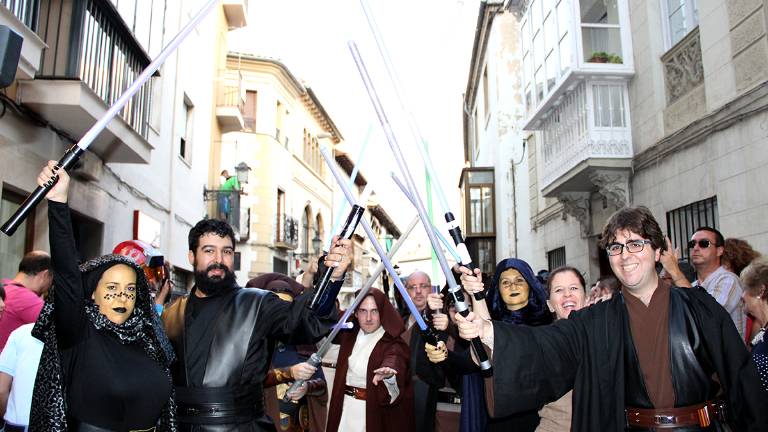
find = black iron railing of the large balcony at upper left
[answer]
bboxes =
[37,0,152,138]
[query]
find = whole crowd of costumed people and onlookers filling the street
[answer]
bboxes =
[0,161,768,432]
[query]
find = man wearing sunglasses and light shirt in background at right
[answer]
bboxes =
[688,226,747,340]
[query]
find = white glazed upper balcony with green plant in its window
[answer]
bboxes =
[515,0,634,130]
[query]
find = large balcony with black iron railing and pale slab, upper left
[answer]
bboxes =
[19,0,152,163]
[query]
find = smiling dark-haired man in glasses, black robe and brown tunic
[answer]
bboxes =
[456,207,768,432]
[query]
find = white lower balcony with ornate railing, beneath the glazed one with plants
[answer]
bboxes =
[540,81,633,196]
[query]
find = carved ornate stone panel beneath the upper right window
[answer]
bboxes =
[661,28,704,103]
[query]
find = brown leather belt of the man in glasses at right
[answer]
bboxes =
[624,401,725,429]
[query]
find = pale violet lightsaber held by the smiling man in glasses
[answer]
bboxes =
[348,42,492,375]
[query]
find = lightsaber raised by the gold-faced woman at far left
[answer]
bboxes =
[0,0,219,236]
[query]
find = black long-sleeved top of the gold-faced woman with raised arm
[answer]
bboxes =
[48,202,171,431]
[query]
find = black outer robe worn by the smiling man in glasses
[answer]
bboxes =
[486,287,768,432]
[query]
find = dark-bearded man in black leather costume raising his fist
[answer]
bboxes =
[162,219,352,432]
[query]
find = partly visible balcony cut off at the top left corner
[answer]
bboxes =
[0,0,46,79]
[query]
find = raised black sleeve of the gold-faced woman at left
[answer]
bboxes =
[48,201,87,349]
